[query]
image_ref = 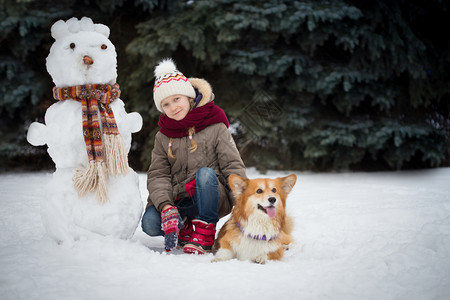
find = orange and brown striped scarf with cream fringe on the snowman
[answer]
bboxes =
[53,84,128,203]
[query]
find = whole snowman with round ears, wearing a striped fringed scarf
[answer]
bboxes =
[27,17,143,245]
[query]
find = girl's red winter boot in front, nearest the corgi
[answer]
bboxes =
[184,220,216,254]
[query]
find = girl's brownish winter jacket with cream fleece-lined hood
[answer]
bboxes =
[147,78,246,218]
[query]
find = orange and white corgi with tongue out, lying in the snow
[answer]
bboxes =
[212,174,297,264]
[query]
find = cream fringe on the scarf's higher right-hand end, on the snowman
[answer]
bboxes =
[102,134,128,175]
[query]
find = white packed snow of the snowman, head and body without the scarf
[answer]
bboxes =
[27,18,143,243]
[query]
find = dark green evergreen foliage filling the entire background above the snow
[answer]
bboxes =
[0,0,450,170]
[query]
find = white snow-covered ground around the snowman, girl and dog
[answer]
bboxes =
[0,168,450,300]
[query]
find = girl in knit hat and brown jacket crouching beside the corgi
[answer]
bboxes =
[142,59,245,254]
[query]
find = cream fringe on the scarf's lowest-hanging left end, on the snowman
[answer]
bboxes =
[72,161,109,204]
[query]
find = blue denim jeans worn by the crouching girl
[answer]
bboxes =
[142,168,219,236]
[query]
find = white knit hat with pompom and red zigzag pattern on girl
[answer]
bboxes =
[153,58,195,112]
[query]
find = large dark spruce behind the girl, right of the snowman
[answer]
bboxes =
[128,0,449,170]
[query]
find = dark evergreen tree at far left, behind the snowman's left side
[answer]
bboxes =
[0,0,72,169]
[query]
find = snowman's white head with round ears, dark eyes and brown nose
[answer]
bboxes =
[46,17,117,87]
